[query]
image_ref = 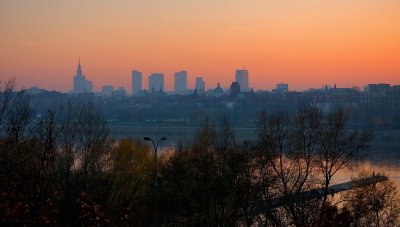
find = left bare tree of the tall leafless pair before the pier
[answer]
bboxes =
[257,108,320,226]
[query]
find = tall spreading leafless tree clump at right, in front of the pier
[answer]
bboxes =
[257,107,372,226]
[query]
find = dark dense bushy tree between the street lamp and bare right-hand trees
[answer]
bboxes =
[160,118,253,226]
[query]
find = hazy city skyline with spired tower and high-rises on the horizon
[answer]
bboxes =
[10,57,400,96]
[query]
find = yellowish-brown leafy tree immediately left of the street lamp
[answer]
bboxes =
[106,139,153,225]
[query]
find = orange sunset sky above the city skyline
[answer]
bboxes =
[0,0,400,92]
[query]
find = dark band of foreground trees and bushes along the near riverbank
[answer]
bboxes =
[0,82,400,226]
